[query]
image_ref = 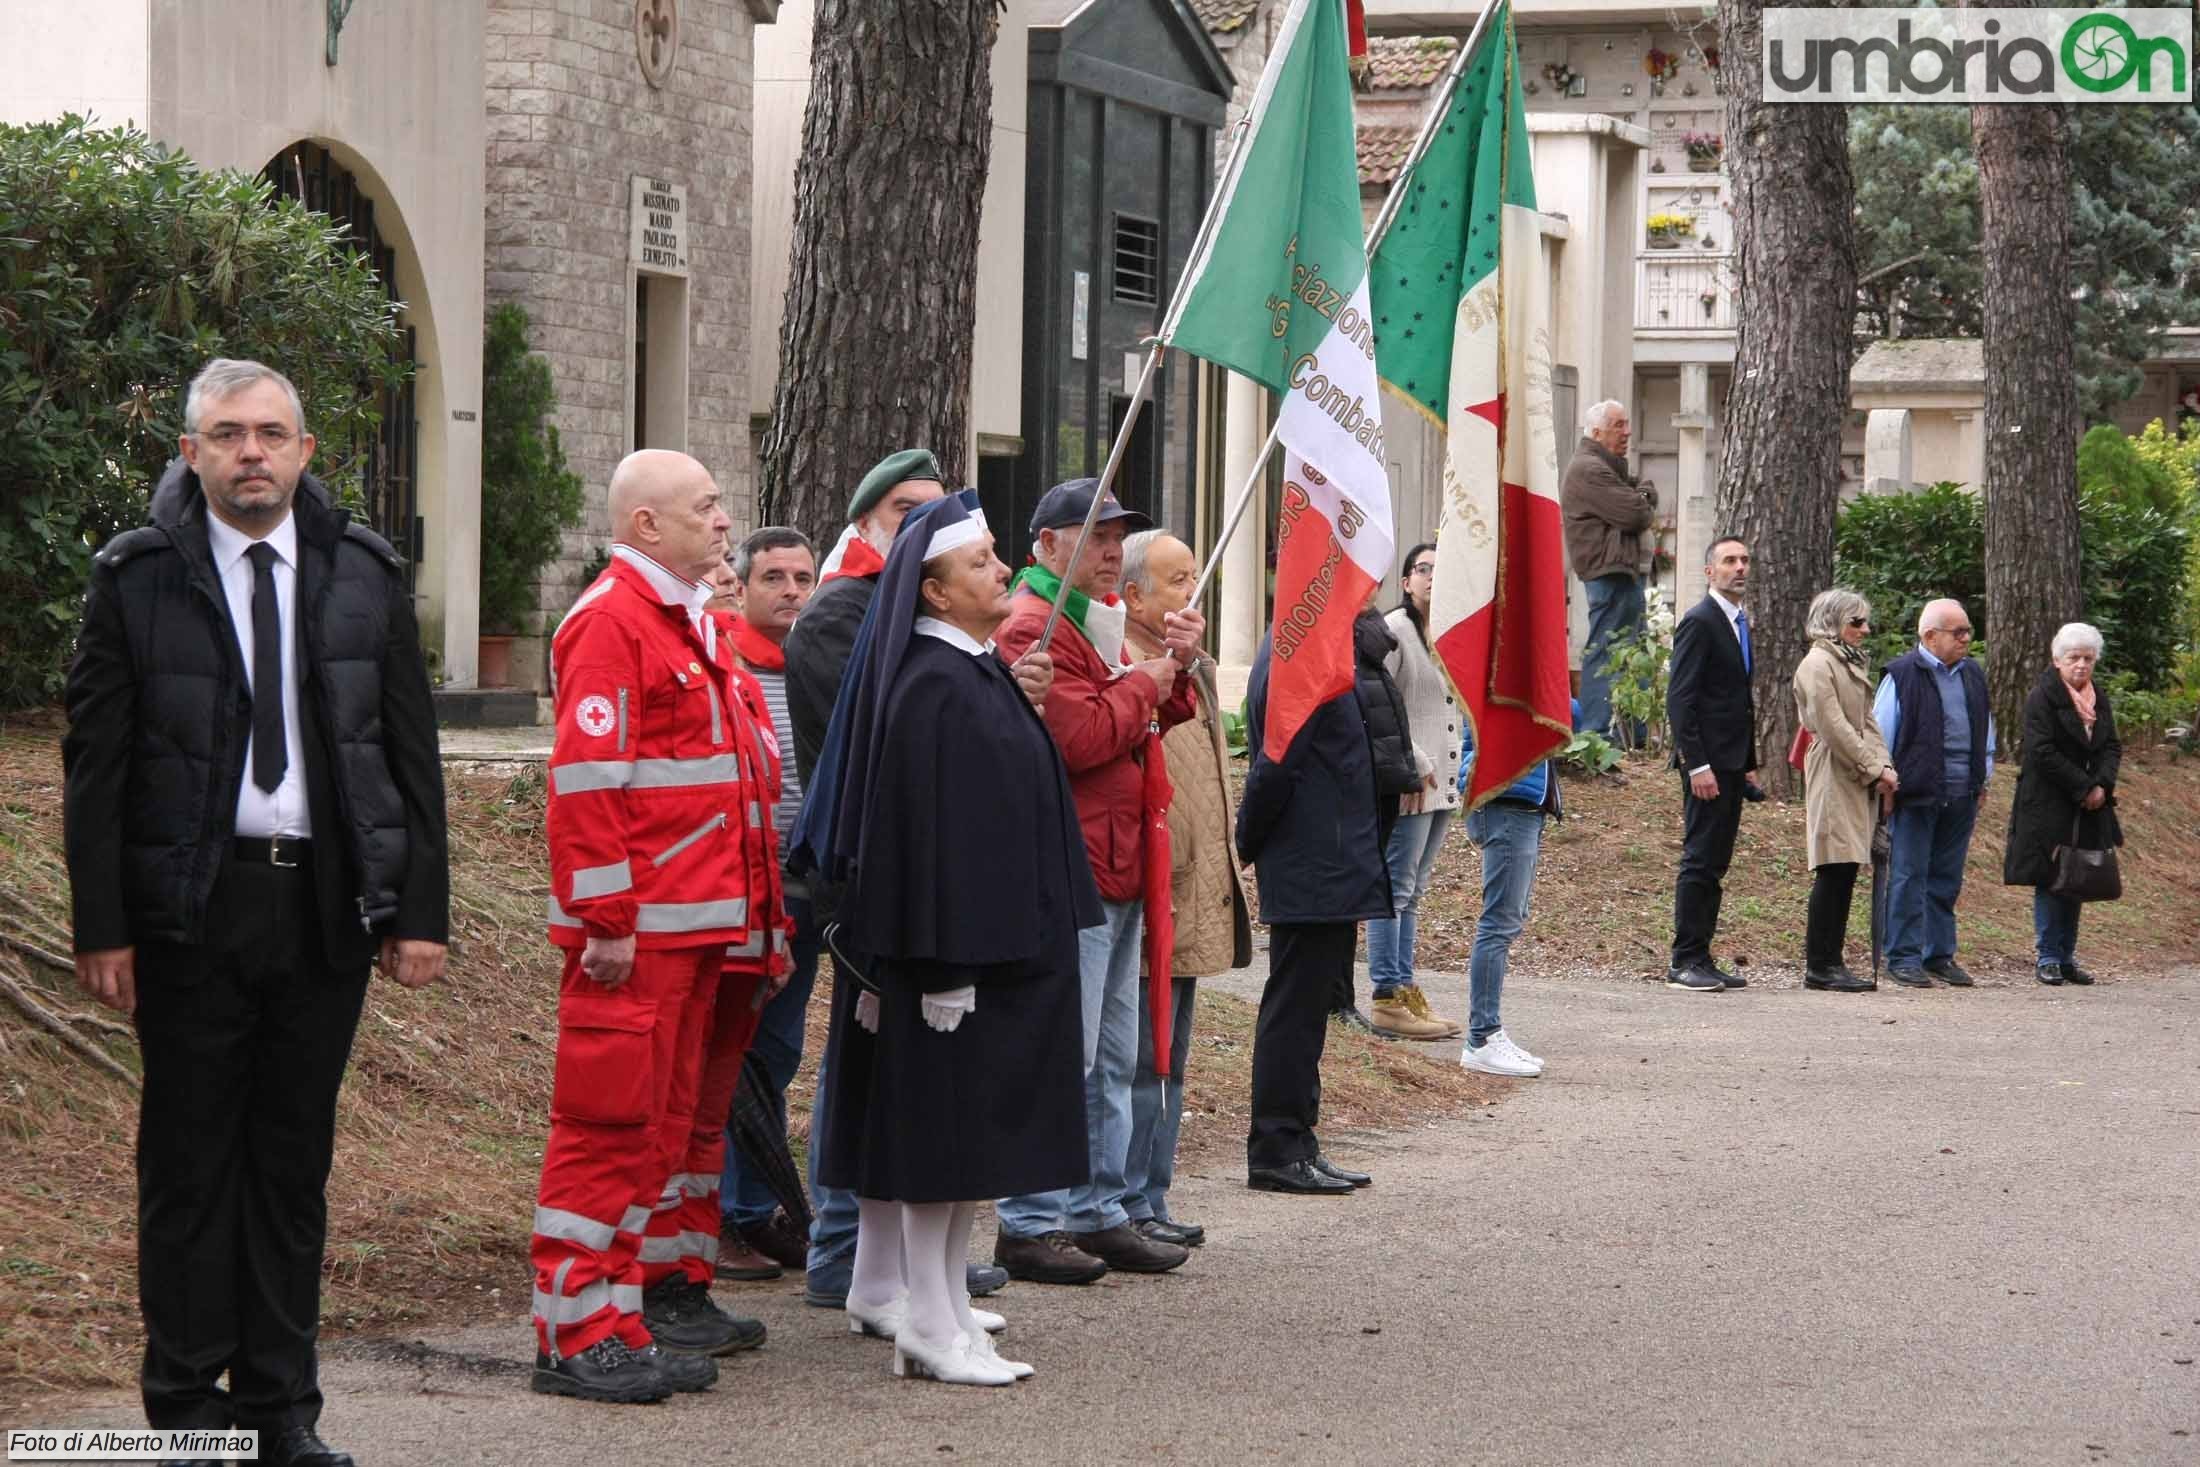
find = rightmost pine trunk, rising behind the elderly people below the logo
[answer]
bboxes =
[1971,81,2076,754]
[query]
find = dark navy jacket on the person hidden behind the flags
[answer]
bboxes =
[1236,642,1397,924]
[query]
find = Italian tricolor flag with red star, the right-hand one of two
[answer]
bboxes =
[1371,4,1573,807]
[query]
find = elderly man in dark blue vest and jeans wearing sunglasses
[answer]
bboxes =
[1872,600,1993,988]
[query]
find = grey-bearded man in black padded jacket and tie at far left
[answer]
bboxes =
[62,361,449,1467]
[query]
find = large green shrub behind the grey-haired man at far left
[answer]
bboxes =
[0,117,407,708]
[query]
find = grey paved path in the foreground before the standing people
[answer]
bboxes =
[40,970,2200,1467]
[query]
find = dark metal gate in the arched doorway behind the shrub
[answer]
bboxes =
[262,141,425,583]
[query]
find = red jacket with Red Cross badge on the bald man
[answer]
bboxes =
[548,545,781,952]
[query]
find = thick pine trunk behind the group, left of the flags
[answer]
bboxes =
[757,0,999,545]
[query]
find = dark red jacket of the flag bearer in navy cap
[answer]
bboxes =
[992,589,1197,902]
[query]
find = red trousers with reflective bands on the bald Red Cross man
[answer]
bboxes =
[530,941,726,1357]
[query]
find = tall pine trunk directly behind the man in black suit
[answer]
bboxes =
[1714,0,1857,798]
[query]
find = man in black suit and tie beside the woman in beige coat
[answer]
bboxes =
[1665,534,1762,994]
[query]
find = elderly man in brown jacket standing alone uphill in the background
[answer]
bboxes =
[1558,402,1657,735]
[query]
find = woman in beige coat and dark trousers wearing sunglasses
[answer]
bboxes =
[1795,587,1894,994]
